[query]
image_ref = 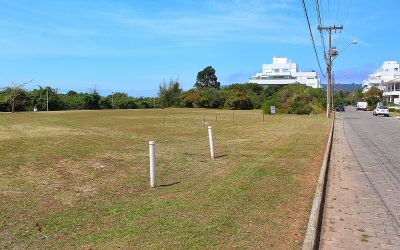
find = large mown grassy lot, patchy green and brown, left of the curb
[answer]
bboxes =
[0,109,329,249]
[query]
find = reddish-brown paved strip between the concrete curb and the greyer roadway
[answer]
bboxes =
[320,114,400,249]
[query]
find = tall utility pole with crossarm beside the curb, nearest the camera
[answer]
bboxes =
[318,25,343,117]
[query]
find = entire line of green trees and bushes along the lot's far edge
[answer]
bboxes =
[0,66,374,114]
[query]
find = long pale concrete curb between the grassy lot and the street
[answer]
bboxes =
[302,113,335,250]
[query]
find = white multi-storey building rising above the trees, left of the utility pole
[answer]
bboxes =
[249,57,321,88]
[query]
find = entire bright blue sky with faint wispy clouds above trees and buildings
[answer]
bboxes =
[0,0,400,96]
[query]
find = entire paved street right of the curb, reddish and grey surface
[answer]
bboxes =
[320,108,400,249]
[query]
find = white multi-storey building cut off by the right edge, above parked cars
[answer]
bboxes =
[363,61,400,104]
